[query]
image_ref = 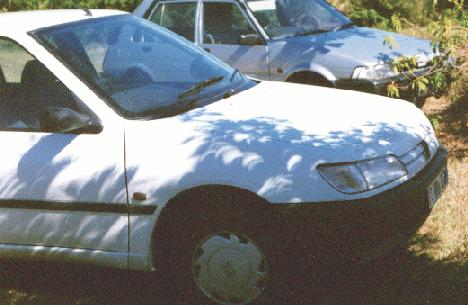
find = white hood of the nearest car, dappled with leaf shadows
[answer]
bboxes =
[175,82,431,162]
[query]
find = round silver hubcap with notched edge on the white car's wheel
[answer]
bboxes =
[192,232,267,304]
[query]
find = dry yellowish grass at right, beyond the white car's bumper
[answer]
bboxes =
[410,81,468,265]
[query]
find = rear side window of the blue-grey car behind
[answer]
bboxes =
[150,2,197,42]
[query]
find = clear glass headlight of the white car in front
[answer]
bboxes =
[317,155,408,194]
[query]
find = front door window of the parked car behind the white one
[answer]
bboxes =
[203,2,257,45]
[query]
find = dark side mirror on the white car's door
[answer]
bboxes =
[40,107,102,134]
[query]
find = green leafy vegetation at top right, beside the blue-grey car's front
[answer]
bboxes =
[332,0,468,102]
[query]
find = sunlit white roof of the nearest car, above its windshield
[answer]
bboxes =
[0,9,127,35]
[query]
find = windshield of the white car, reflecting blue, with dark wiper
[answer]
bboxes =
[34,15,255,118]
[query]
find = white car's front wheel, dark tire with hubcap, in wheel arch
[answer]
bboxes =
[154,190,287,305]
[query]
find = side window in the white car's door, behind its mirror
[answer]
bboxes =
[0,37,86,131]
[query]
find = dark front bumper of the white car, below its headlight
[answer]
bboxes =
[274,146,447,265]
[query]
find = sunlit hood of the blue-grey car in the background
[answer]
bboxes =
[292,27,434,65]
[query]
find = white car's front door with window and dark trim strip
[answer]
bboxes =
[0,37,128,254]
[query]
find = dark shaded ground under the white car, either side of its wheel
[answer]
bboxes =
[0,235,468,305]
